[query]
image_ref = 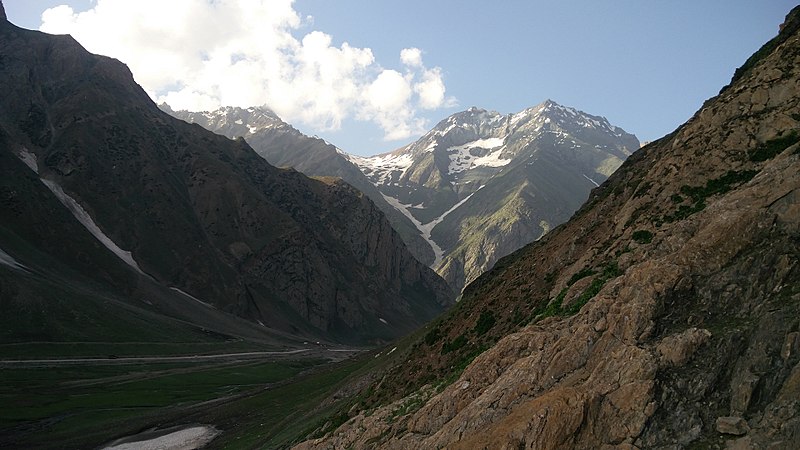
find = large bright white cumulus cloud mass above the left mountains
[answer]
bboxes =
[40,0,454,140]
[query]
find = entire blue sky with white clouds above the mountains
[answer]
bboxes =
[3,0,797,155]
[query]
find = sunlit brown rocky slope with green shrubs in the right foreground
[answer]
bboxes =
[298,8,800,449]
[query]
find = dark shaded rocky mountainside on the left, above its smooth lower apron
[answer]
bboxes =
[0,14,452,343]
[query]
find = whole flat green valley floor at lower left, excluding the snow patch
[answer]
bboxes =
[0,344,381,449]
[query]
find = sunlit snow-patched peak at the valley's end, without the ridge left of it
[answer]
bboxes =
[351,100,639,289]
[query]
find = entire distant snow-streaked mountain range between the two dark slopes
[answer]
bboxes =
[167,100,639,290]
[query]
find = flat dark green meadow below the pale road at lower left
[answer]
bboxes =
[0,360,322,448]
